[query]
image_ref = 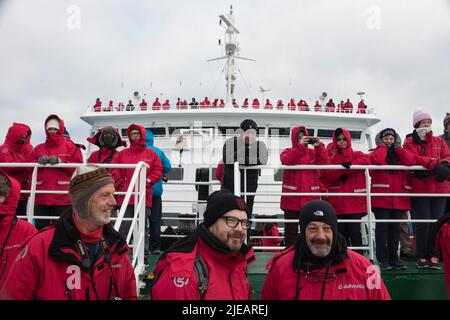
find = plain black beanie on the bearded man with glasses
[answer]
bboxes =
[203,189,250,227]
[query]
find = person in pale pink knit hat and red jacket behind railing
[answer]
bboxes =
[404,111,450,269]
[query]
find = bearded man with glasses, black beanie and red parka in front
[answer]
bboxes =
[152,190,255,300]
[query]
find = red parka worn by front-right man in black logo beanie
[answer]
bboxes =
[260,246,390,300]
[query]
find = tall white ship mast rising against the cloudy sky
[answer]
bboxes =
[208,5,256,108]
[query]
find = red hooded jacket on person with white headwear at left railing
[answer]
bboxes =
[29,114,83,206]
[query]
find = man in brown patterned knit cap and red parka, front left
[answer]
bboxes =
[0,165,137,300]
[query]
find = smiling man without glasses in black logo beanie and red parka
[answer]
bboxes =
[261,200,390,300]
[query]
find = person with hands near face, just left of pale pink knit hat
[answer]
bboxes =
[370,128,415,270]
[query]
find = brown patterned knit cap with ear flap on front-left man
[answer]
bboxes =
[69,165,114,218]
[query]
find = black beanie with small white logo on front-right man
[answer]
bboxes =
[300,200,338,242]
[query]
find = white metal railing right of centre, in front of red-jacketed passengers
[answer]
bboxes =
[234,162,450,260]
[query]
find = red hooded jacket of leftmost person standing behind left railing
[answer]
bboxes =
[0,123,33,200]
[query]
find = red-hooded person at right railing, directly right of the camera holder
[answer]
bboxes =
[322,128,370,254]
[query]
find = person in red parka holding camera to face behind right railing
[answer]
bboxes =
[280,126,330,245]
